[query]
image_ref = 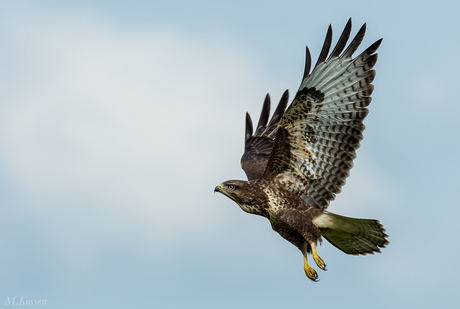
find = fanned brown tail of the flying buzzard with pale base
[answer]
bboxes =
[313,211,389,255]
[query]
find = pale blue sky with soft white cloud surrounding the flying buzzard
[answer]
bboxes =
[0,0,460,308]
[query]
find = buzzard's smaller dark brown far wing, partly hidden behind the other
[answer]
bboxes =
[241,90,289,180]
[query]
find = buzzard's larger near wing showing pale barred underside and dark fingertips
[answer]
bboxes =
[264,20,381,209]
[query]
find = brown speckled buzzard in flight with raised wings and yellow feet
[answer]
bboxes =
[214,19,388,281]
